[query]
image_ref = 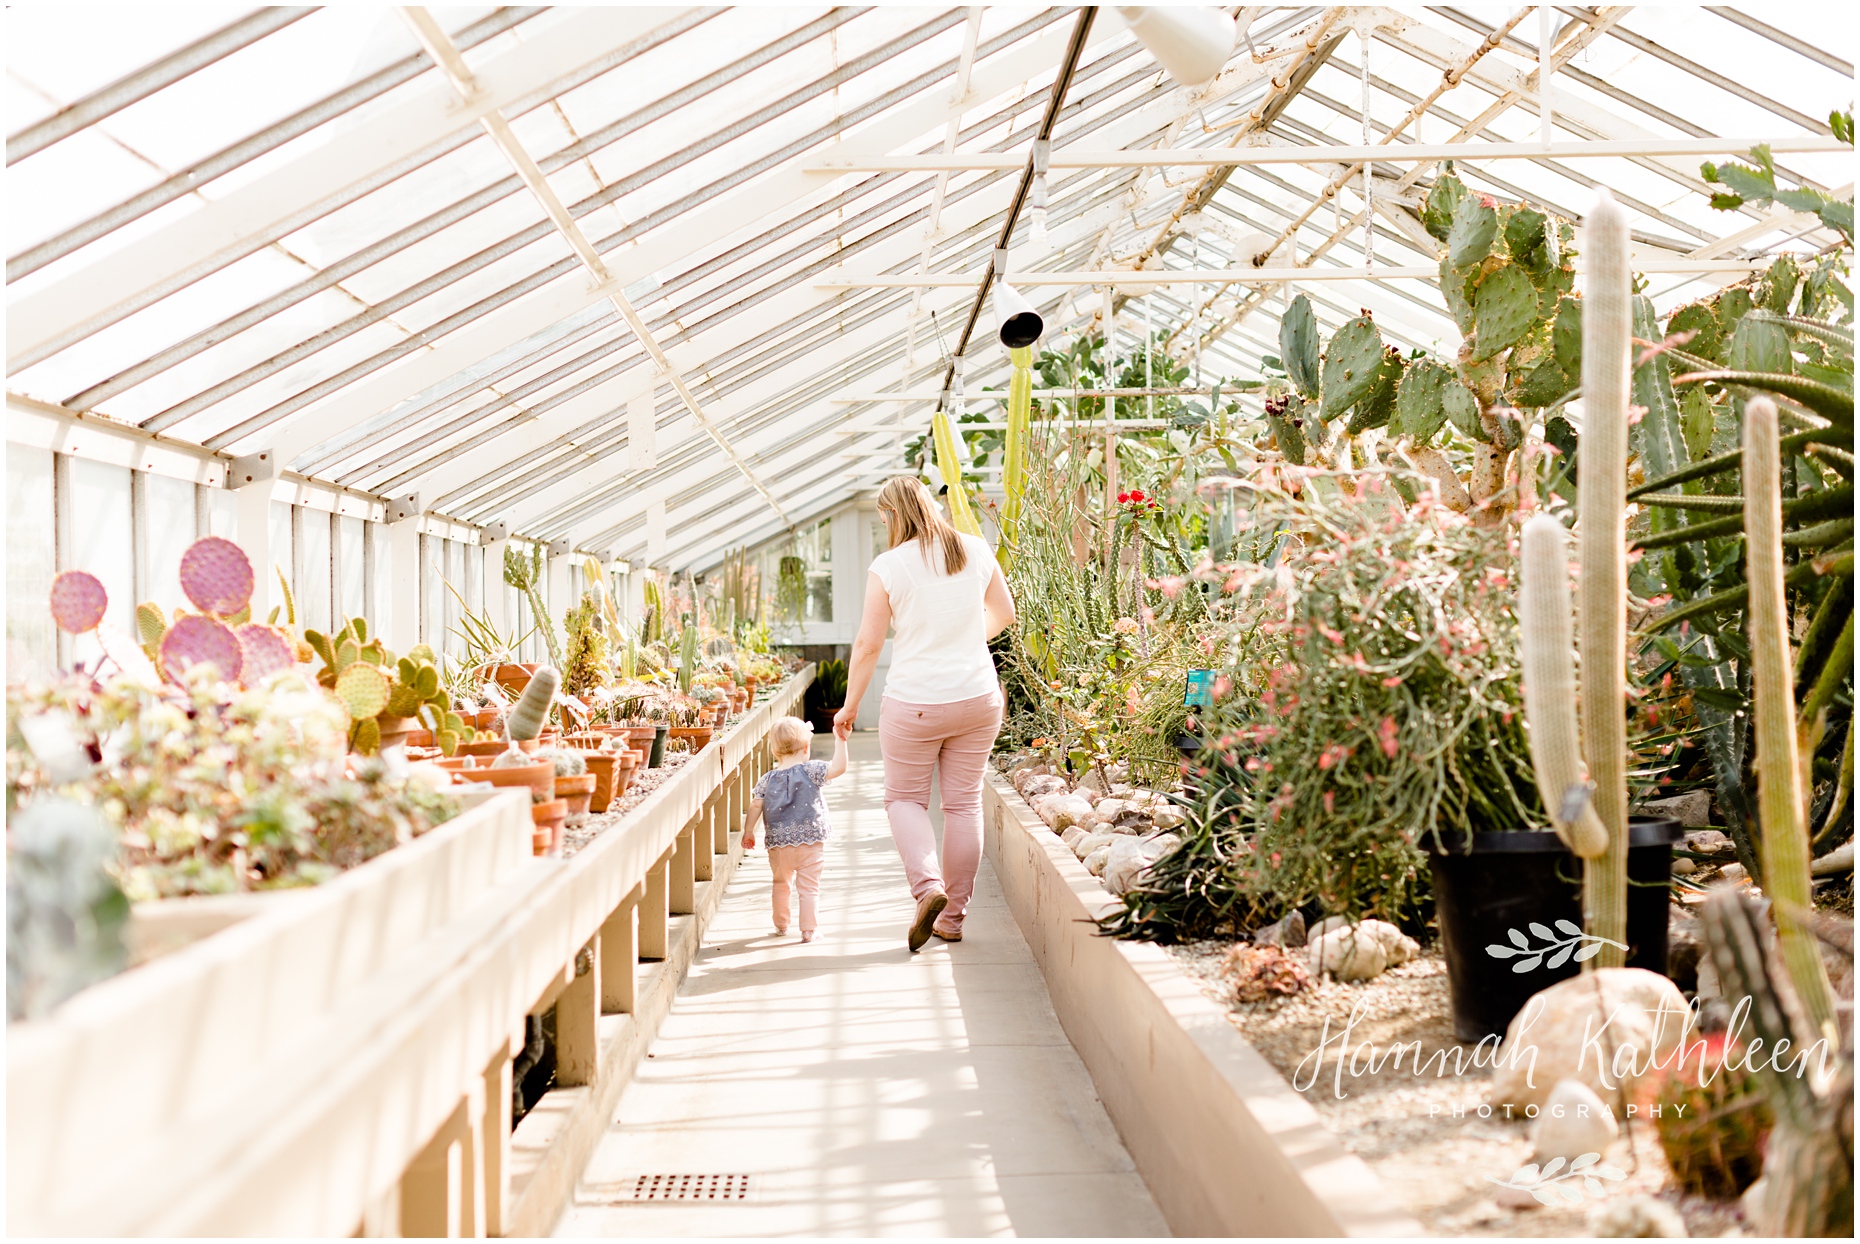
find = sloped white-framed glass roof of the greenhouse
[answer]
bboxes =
[6,6,1854,569]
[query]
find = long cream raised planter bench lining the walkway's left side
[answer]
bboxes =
[7,669,813,1235]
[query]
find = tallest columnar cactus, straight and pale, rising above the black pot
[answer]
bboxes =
[1584,190,1633,967]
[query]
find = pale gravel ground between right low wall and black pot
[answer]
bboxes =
[1166,939,1743,1237]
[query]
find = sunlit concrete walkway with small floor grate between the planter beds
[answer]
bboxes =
[556,734,1168,1237]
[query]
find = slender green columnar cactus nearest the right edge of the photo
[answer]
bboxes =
[1743,398,1834,1039]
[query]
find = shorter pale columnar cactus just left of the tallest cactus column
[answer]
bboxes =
[1518,513,1609,859]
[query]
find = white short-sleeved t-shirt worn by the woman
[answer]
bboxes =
[872,536,997,705]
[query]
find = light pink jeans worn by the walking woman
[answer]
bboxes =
[878,692,1001,930]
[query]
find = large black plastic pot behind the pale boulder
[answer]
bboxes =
[1428,816,1685,1041]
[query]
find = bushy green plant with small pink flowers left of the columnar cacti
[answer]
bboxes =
[1116,470,1548,935]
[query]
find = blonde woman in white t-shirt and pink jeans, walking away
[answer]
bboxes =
[833,476,1014,952]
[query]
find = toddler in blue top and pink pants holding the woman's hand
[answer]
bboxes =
[742,718,846,941]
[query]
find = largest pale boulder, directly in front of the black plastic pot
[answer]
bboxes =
[1492,967,1689,1108]
